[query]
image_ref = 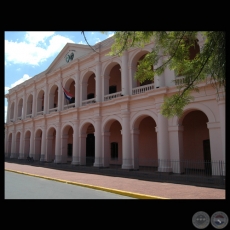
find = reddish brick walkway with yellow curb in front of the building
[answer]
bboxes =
[5,162,226,199]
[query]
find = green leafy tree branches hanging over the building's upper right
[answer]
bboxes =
[105,31,226,118]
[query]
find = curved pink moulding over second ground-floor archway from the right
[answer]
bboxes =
[130,110,157,130]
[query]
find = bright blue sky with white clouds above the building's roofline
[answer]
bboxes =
[5,31,113,121]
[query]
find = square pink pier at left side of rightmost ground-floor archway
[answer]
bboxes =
[168,125,184,173]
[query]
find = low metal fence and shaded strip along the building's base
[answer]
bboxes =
[5,154,226,189]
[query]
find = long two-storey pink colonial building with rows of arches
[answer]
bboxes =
[5,34,225,175]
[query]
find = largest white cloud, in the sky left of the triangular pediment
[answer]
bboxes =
[5,32,74,66]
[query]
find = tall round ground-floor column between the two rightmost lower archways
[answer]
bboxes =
[156,104,172,172]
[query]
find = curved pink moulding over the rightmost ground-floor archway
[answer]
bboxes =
[170,103,216,126]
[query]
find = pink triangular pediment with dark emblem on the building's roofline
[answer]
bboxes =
[46,43,92,74]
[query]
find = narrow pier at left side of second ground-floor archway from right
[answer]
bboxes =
[131,129,140,169]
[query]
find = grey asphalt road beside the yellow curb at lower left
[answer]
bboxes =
[5,171,135,199]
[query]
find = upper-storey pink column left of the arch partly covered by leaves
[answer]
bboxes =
[121,51,130,96]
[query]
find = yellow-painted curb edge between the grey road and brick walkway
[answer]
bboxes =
[5,169,169,200]
